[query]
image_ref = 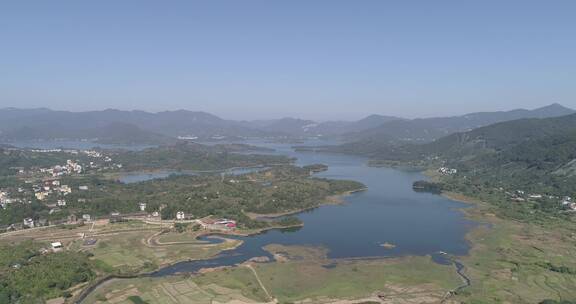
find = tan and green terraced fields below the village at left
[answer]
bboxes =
[0,221,241,274]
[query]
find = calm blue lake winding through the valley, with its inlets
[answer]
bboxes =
[7,141,476,276]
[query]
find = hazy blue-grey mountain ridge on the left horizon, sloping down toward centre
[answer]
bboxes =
[0,108,265,143]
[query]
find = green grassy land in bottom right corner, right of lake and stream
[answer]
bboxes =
[456,198,576,303]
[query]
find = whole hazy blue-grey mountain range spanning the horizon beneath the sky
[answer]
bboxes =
[0,104,574,144]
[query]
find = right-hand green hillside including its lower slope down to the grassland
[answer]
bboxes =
[346,114,576,220]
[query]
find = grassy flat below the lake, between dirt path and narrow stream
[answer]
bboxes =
[255,257,462,303]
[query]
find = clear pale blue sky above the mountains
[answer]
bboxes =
[0,0,576,120]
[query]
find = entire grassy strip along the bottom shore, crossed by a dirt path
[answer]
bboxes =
[87,245,462,304]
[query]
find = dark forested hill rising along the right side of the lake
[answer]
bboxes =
[364,114,576,195]
